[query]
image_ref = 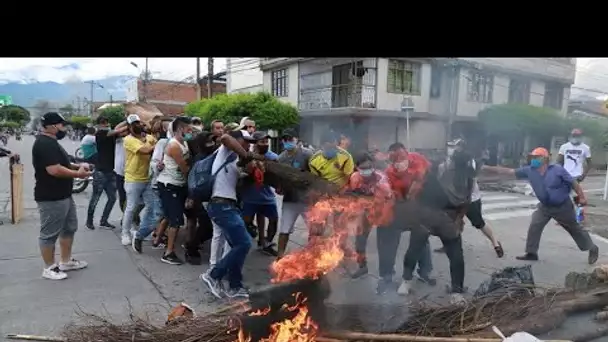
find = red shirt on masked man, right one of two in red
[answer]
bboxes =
[386,152,431,199]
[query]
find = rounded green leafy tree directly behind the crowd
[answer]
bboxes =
[185,92,300,130]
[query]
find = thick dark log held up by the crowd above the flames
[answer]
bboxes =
[264,162,339,198]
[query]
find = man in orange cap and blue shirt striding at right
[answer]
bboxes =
[482,147,599,264]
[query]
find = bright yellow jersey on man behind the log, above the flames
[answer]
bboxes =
[308,147,355,186]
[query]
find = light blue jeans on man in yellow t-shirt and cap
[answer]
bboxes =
[122,182,156,237]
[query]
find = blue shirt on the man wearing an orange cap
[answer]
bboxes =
[515,164,573,206]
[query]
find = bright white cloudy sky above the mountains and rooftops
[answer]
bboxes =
[0,57,608,97]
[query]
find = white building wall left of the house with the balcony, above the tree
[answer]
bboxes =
[226,57,264,93]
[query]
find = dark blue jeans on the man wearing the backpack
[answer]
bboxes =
[207,203,252,289]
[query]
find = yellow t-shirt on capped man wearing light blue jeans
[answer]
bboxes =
[123,135,156,183]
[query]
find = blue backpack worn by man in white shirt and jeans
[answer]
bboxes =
[188,151,236,202]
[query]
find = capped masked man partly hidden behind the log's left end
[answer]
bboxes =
[276,129,313,259]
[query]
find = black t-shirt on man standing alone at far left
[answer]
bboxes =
[32,134,73,202]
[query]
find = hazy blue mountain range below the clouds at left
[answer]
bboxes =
[0,76,135,108]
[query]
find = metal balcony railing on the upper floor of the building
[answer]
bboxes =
[299,84,376,111]
